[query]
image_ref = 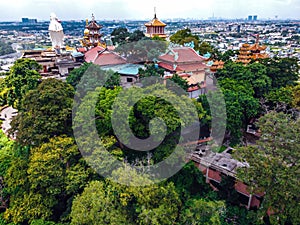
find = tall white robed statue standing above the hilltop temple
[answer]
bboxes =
[48,13,64,49]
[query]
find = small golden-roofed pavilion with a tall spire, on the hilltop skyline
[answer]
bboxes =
[145,9,167,38]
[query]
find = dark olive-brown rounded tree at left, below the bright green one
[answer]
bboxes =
[10,79,74,146]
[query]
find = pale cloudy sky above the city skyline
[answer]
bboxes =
[0,0,300,21]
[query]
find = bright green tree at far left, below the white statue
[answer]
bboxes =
[5,59,42,109]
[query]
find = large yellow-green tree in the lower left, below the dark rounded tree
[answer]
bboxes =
[5,136,89,223]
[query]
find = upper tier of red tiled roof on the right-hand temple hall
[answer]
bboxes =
[158,47,205,63]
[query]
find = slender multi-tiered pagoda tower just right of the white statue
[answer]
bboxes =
[81,15,105,48]
